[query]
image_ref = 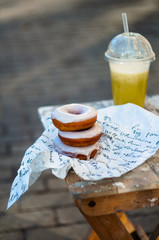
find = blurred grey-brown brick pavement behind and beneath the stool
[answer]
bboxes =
[0,0,159,240]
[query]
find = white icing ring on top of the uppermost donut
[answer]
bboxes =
[51,103,97,123]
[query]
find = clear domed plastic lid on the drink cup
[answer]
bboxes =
[105,32,155,62]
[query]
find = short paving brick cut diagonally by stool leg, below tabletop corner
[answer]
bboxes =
[56,206,86,224]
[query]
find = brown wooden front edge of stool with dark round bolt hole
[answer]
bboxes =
[78,189,159,216]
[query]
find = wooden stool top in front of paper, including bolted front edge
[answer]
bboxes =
[66,152,159,215]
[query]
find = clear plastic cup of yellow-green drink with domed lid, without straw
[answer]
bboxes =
[105,32,155,107]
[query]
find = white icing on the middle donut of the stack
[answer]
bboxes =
[59,123,102,139]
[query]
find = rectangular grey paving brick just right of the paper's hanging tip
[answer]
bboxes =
[21,192,73,210]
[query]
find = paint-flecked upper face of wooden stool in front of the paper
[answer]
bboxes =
[66,154,159,199]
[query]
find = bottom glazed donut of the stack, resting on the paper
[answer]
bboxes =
[54,136,99,160]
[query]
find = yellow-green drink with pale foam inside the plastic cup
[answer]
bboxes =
[111,62,149,107]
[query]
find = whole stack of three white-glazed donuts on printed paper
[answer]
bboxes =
[51,104,102,160]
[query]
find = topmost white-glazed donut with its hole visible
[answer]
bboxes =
[51,103,97,131]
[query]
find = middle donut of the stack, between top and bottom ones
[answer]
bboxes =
[58,123,102,147]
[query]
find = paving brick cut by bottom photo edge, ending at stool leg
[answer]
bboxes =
[28,224,90,240]
